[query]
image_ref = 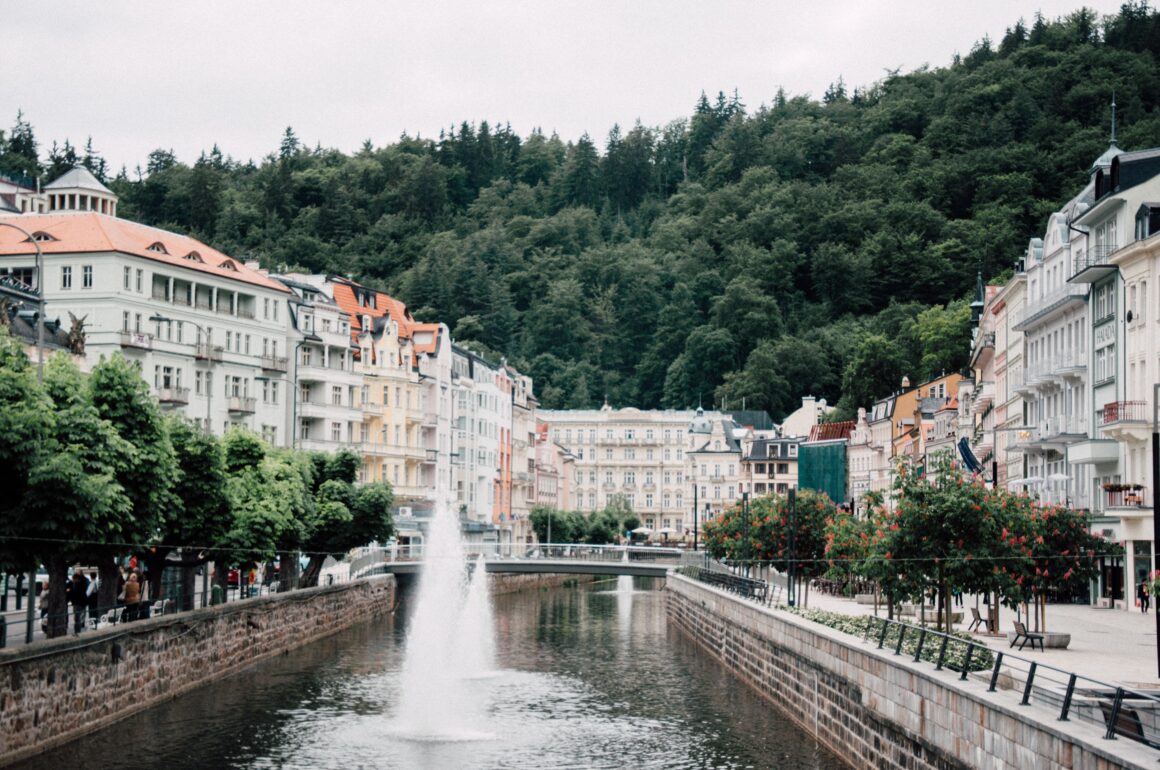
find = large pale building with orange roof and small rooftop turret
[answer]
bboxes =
[0,169,295,437]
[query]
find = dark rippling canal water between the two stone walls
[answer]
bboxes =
[16,579,844,770]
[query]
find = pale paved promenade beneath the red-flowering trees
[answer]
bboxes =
[809,591,1160,689]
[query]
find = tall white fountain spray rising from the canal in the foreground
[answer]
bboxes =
[396,501,494,741]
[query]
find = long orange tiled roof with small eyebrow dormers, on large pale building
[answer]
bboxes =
[0,211,290,293]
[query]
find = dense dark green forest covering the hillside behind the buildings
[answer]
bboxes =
[0,2,1160,419]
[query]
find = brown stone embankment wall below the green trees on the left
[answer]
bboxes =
[0,575,394,765]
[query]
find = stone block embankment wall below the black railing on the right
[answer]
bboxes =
[666,575,1157,770]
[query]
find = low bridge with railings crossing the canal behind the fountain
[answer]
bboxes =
[350,543,682,578]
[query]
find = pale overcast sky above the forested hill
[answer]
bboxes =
[0,0,1122,170]
